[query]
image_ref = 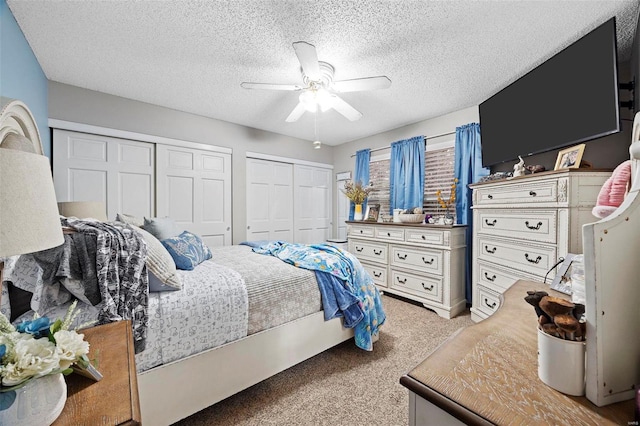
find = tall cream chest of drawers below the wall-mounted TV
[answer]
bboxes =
[470,169,611,322]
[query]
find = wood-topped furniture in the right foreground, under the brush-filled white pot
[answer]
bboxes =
[400,281,637,425]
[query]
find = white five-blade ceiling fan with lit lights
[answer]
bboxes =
[240,41,391,122]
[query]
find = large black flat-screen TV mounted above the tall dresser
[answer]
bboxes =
[479,18,621,167]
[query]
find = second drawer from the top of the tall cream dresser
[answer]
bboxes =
[476,209,558,244]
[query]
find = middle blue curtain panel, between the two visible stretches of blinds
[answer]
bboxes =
[389,136,425,214]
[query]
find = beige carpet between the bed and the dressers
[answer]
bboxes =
[172,295,472,426]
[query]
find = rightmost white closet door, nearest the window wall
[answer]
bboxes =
[294,164,332,244]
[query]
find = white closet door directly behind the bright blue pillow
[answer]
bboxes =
[156,144,231,247]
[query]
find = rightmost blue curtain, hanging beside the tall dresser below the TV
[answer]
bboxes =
[454,123,489,302]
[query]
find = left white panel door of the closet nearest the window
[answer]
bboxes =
[246,158,293,241]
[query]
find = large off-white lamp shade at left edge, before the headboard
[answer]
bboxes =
[0,148,64,257]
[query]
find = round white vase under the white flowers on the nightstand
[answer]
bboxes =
[0,373,67,426]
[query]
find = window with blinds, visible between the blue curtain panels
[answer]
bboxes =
[368,141,455,215]
